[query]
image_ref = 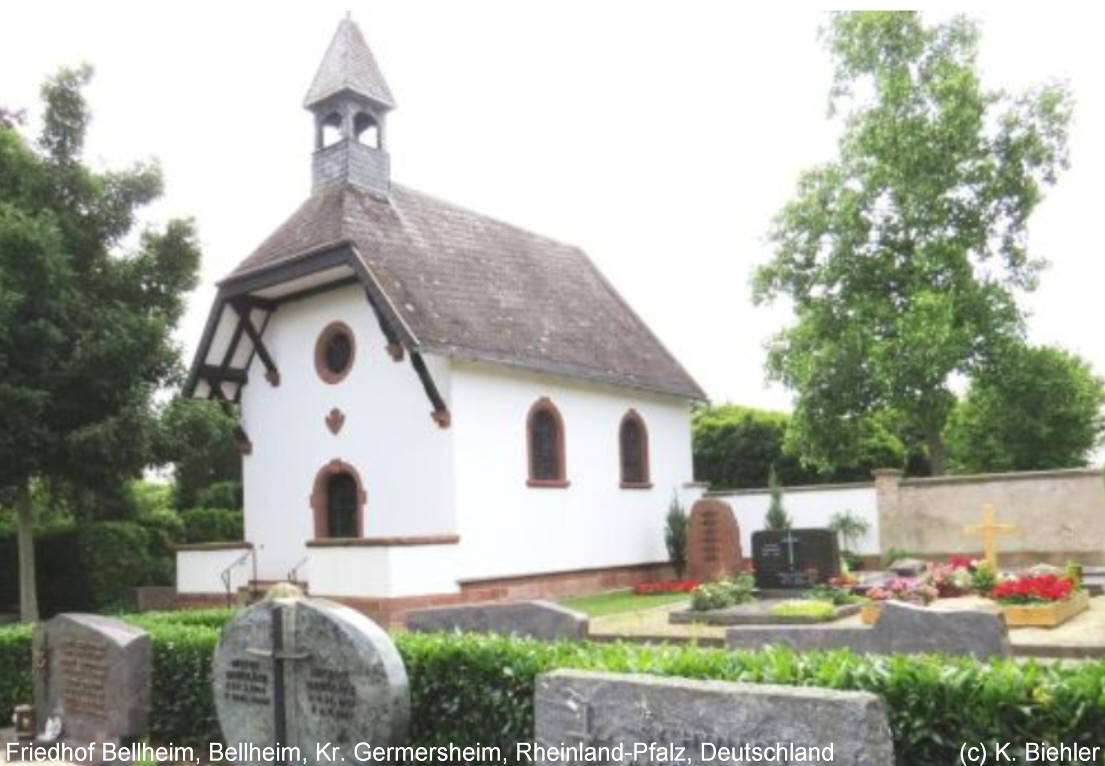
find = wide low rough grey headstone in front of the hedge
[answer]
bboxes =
[535,670,894,766]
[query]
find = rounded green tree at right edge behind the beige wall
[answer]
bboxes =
[946,345,1105,473]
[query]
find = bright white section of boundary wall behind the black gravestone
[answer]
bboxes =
[707,483,880,557]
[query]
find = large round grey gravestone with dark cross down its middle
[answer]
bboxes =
[212,597,410,765]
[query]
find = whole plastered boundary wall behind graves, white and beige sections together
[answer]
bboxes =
[706,469,1105,566]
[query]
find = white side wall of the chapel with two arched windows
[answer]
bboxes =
[451,359,697,580]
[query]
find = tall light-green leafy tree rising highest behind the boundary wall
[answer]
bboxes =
[754,12,1070,473]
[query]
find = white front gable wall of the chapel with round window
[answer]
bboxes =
[242,285,456,579]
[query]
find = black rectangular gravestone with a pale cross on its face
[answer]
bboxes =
[753,529,840,590]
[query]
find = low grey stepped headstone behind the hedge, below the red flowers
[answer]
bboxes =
[725,601,1011,659]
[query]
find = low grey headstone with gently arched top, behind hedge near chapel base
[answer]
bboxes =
[404,601,590,639]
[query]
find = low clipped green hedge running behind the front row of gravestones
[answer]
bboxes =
[0,610,1105,766]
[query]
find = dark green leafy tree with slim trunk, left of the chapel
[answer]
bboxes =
[0,66,199,616]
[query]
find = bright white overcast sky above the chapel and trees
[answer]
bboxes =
[0,0,1105,409]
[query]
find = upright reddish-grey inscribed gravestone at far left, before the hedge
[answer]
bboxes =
[33,613,152,744]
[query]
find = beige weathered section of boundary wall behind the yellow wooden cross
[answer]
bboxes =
[875,469,1105,566]
